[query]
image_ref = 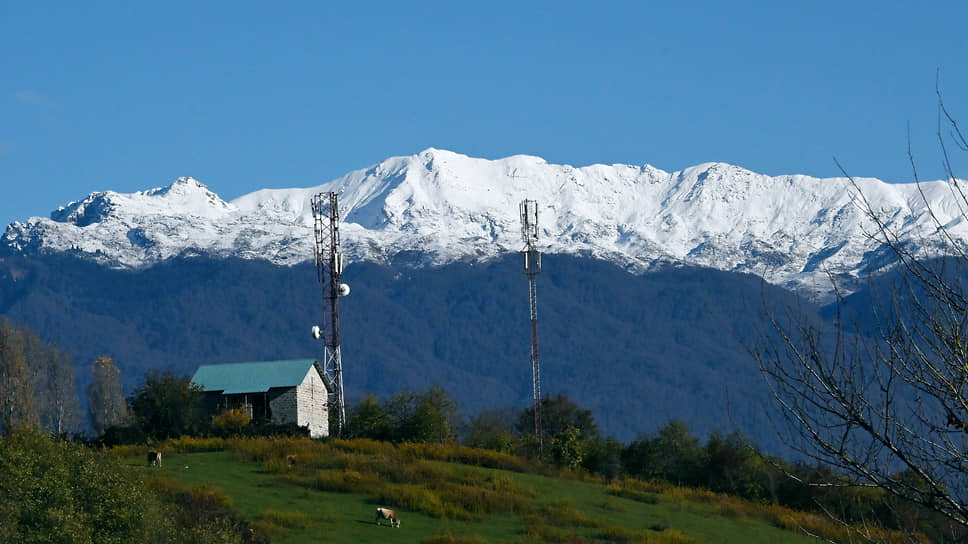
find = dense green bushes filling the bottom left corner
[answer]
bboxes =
[0,430,253,544]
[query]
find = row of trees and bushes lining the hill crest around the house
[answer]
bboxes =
[0,320,965,536]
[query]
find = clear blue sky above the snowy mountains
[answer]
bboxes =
[0,0,968,225]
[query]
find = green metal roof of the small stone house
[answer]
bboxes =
[192,359,326,395]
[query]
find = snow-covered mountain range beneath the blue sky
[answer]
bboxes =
[2,149,968,293]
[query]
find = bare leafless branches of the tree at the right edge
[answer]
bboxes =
[753,85,968,534]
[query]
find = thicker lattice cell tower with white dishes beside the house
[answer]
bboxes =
[312,193,350,436]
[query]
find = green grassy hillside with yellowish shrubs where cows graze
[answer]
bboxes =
[115,440,815,543]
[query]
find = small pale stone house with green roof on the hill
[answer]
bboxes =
[192,359,330,438]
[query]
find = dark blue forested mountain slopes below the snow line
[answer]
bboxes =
[0,255,817,451]
